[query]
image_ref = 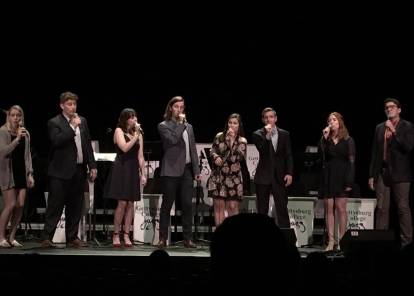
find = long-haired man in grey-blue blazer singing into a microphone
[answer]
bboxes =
[158,96,201,248]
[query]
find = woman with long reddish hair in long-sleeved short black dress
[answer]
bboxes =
[319,112,355,251]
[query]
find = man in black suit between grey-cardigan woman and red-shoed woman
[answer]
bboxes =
[42,92,97,248]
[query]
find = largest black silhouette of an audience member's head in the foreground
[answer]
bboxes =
[210,213,300,292]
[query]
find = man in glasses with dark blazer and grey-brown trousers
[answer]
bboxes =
[368,98,414,246]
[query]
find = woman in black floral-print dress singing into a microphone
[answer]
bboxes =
[207,113,246,226]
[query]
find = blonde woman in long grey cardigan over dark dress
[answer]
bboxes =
[0,105,34,248]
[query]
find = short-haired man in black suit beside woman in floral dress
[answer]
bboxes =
[253,108,293,228]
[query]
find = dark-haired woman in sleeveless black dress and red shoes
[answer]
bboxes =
[106,108,147,248]
